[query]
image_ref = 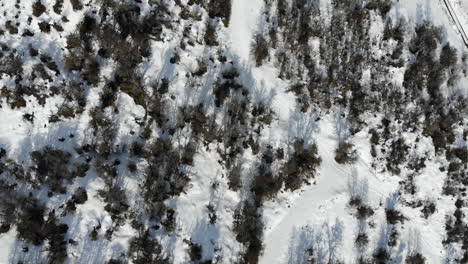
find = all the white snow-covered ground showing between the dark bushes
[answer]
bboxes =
[0,0,468,264]
